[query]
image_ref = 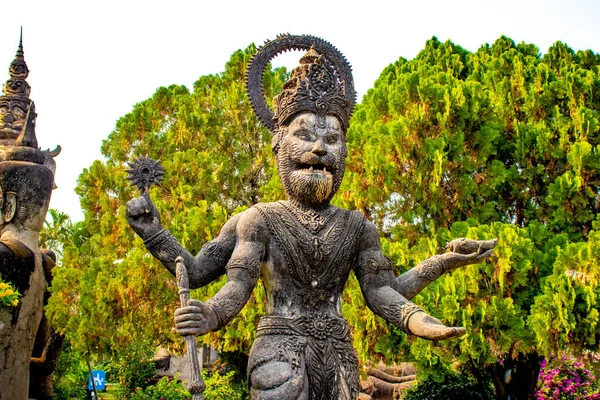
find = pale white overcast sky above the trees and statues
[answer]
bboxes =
[0,0,600,220]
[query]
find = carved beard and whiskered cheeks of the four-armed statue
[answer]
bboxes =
[276,133,346,207]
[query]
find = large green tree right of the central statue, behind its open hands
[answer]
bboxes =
[341,37,600,399]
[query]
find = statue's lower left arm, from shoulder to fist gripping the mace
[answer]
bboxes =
[175,208,267,336]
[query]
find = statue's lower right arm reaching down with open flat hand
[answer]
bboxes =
[355,222,465,340]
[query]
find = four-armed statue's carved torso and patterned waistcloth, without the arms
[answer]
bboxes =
[248,202,365,400]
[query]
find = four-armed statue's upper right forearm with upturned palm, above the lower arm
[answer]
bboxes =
[391,238,498,300]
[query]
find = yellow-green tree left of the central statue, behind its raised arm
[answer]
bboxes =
[48,45,286,366]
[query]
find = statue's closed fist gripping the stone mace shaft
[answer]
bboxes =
[175,299,218,336]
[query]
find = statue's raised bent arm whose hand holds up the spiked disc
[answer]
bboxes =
[126,193,239,289]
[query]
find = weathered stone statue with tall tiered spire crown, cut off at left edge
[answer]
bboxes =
[0,34,59,400]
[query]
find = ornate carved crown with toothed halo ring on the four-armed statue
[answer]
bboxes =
[246,34,356,132]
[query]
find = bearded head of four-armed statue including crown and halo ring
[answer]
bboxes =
[247,35,356,208]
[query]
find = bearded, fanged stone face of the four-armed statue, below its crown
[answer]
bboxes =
[277,113,347,206]
